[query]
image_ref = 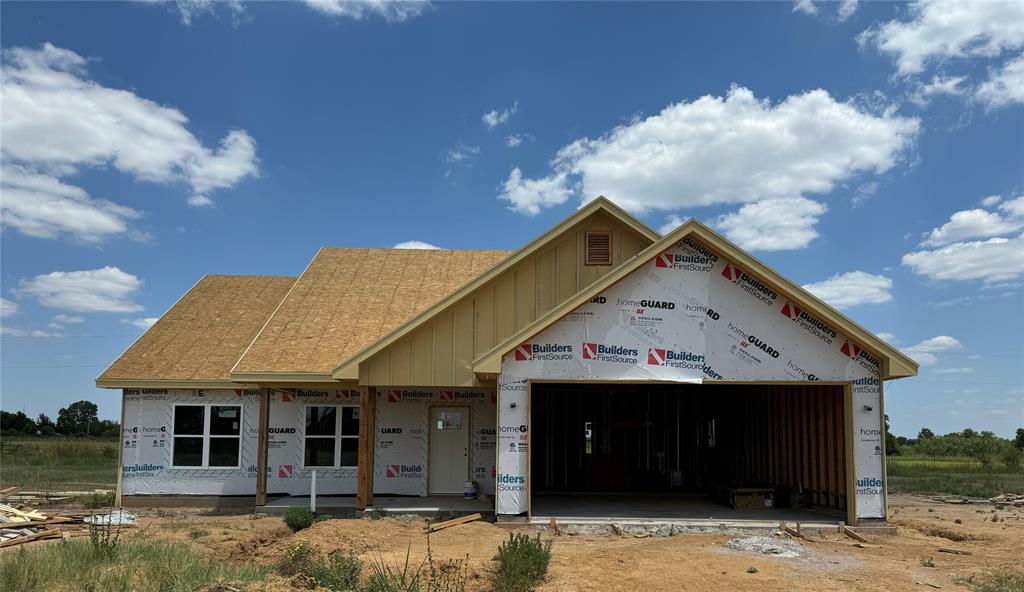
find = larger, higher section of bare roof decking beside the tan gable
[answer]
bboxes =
[232,247,511,375]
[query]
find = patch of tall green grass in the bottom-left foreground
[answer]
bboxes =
[0,539,266,592]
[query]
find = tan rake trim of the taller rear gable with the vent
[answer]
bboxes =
[333,196,660,380]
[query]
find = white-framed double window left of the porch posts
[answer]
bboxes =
[171,405,242,469]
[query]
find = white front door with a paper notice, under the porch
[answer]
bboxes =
[430,407,469,494]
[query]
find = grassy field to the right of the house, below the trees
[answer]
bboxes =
[886,456,1024,498]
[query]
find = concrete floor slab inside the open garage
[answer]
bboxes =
[530,494,844,528]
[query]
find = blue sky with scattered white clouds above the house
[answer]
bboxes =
[0,0,1024,435]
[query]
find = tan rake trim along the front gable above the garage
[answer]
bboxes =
[473,219,918,380]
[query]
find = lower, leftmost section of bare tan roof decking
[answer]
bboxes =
[96,276,296,382]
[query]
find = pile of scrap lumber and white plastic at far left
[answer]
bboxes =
[0,499,135,547]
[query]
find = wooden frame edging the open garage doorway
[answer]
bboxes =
[526,379,860,525]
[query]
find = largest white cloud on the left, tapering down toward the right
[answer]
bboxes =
[0,43,259,217]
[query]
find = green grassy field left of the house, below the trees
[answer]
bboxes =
[0,436,119,491]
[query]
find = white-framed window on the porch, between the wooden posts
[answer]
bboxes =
[303,405,359,469]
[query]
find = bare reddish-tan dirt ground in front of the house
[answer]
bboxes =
[112,496,1024,592]
